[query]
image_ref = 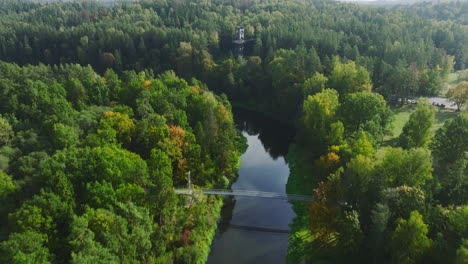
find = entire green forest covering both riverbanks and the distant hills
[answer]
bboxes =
[0,0,468,263]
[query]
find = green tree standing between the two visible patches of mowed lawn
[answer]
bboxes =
[398,100,435,149]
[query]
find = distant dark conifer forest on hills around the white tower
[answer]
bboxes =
[0,0,468,120]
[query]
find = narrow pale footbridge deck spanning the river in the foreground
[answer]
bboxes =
[175,189,312,202]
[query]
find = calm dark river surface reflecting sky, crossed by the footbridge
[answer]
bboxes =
[208,110,295,264]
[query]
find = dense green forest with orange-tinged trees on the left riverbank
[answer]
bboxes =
[0,63,247,263]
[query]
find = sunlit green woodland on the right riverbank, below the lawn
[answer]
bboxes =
[288,76,468,263]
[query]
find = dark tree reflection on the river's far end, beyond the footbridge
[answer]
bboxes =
[234,109,295,160]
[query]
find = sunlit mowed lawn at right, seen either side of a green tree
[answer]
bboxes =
[385,105,460,144]
